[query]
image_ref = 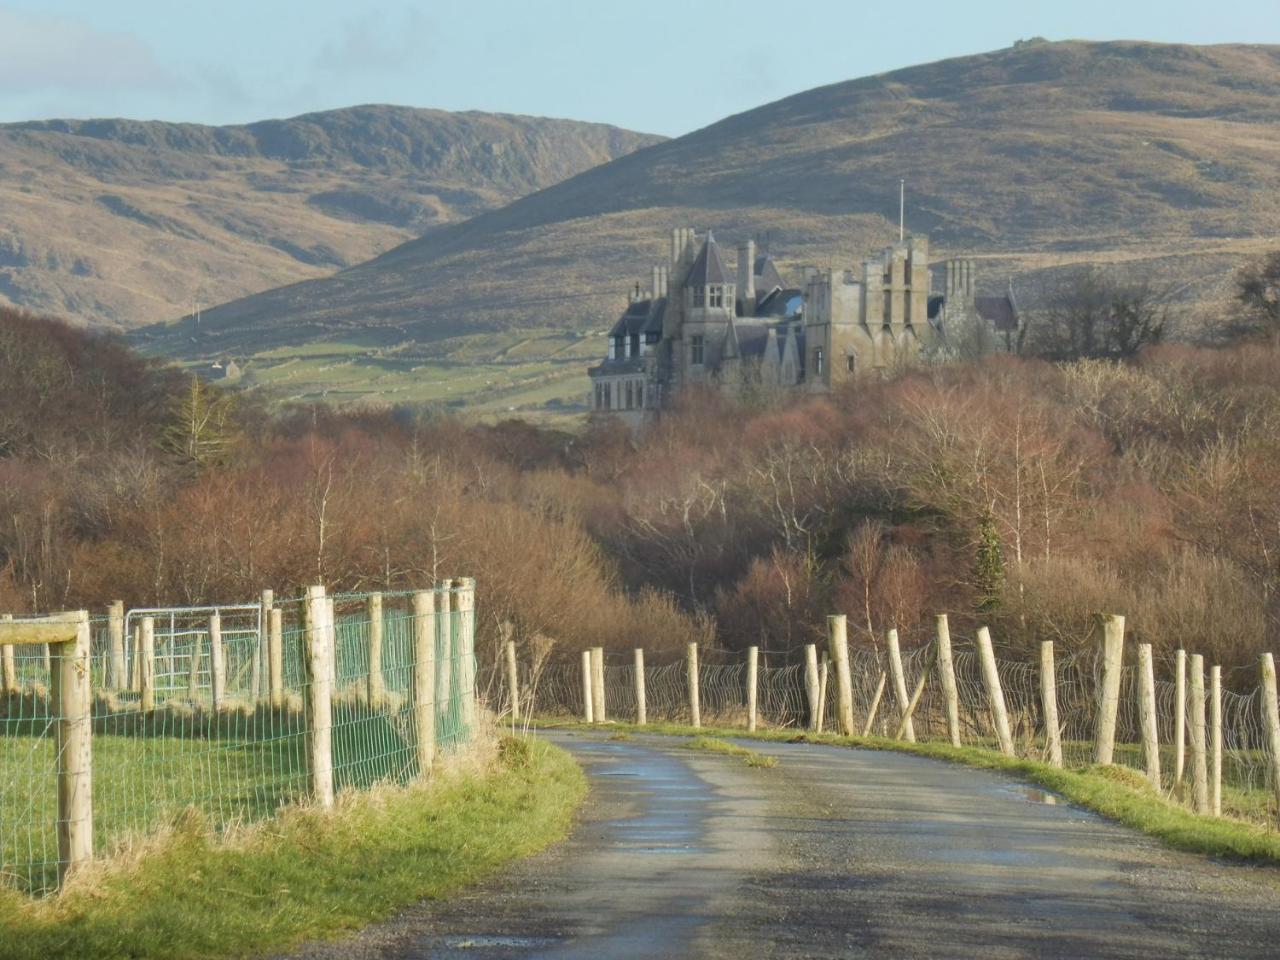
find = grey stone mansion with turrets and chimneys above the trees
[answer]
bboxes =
[588,228,1018,425]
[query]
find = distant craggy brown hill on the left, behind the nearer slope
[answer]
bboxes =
[0,106,659,328]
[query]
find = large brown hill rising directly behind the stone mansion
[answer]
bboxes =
[138,41,1280,414]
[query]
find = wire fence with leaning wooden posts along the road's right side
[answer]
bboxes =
[483,617,1280,829]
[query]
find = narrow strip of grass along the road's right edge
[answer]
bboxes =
[543,722,1280,865]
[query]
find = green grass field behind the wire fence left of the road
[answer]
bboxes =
[0,704,416,892]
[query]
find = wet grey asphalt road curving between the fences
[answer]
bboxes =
[285,733,1280,960]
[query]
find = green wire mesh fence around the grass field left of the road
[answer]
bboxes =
[0,580,476,893]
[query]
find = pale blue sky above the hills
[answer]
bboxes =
[0,0,1280,136]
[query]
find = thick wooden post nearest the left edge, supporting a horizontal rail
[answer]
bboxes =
[54,611,93,886]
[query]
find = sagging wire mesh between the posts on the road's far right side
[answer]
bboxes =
[484,627,1277,826]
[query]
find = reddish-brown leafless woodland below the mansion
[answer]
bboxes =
[0,253,1280,664]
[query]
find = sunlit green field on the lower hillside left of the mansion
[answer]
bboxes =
[207,329,607,420]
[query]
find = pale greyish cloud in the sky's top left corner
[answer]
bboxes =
[0,9,178,96]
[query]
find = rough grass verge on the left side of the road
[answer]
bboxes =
[0,739,586,960]
